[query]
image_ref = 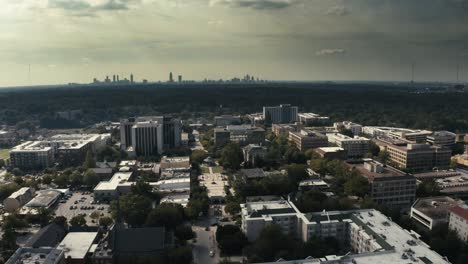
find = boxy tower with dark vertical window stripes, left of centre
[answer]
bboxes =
[132,121,163,157]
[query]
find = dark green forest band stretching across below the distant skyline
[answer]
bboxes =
[0,83,468,131]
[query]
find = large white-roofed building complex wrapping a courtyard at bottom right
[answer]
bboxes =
[241,199,449,264]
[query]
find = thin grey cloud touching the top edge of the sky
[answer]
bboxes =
[210,0,298,10]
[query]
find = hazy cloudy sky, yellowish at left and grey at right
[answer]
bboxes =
[0,0,468,87]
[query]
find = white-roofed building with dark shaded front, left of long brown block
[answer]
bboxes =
[327,133,370,158]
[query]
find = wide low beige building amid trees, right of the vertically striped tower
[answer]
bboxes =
[214,125,265,146]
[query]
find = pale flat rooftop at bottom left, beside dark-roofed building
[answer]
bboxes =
[57,232,97,259]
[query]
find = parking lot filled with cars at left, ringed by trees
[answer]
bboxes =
[55,192,110,226]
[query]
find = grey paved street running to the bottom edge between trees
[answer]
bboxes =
[192,209,220,264]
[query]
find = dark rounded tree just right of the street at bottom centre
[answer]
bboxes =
[216,225,247,255]
